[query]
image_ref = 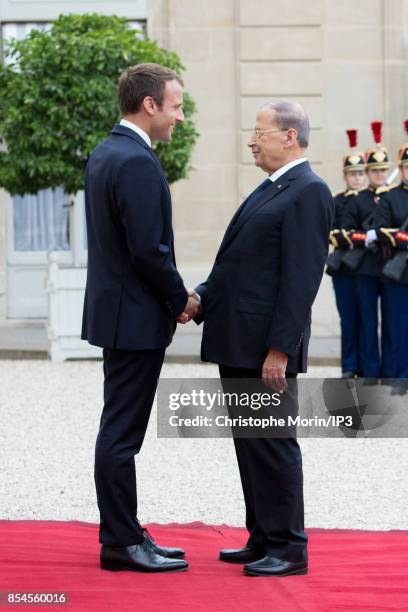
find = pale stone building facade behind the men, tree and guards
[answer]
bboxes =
[0,0,408,344]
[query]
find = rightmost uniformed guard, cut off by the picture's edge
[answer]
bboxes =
[374,120,408,395]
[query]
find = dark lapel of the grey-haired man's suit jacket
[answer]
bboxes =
[218,162,311,255]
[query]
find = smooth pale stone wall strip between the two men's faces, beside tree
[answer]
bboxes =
[148,0,239,272]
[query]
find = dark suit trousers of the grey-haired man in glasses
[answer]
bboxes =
[219,365,307,561]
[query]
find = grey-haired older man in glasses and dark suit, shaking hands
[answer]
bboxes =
[196,101,334,576]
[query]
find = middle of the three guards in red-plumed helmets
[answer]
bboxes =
[342,121,392,379]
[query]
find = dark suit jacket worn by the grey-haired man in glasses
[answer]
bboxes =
[196,162,334,373]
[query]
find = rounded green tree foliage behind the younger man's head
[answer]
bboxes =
[0,14,198,195]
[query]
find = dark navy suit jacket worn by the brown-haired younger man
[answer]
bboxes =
[82,124,188,350]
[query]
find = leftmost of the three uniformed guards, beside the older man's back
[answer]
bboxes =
[326,130,366,378]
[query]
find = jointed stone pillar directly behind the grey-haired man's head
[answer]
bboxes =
[239,0,324,197]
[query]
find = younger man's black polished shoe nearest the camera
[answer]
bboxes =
[101,540,188,572]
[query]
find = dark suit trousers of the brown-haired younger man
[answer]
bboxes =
[95,348,165,546]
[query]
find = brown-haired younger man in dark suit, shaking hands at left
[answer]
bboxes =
[82,64,199,572]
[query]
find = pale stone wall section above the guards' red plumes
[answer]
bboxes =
[324,0,408,190]
